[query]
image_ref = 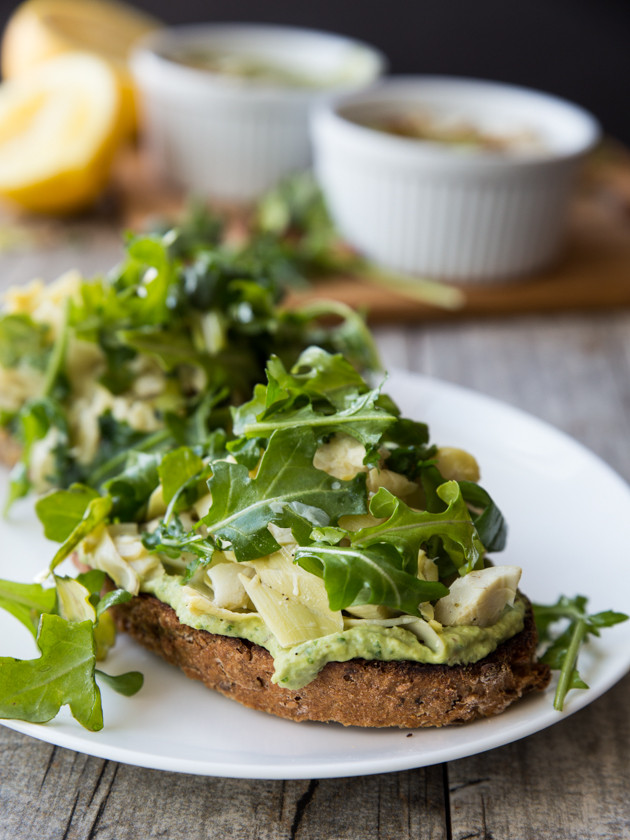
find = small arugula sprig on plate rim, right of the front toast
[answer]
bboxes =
[532,595,628,712]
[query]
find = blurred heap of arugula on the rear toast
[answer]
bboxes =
[0,200,379,506]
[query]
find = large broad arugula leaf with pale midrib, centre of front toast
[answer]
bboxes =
[201,428,366,560]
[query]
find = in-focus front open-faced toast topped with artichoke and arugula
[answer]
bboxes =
[0,347,549,727]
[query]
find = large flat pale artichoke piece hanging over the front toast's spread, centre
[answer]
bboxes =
[241,552,343,647]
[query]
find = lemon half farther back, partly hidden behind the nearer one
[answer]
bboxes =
[2,0,160,134]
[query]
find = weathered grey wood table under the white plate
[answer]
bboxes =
[0,218,630,840]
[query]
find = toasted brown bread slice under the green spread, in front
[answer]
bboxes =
[115,594,550,728]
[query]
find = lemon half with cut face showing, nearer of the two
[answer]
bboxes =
[0,53,120,213]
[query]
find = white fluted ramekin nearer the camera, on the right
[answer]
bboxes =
[312,76,599,282]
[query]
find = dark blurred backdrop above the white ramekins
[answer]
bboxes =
[0,0,630,143]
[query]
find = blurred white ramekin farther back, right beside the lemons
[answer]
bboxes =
[131,24,385,201]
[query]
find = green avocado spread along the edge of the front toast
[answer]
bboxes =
[141,573,525,689]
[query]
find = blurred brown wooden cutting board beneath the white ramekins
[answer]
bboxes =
[116,142,630,323]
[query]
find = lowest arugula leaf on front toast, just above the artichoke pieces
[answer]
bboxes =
[295,543,448,617]
